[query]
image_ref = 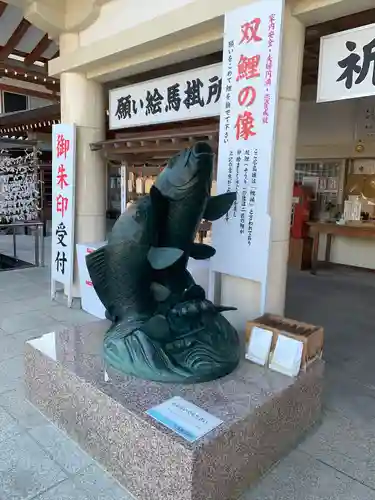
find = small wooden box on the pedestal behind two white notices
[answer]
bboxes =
[246,314,324,370]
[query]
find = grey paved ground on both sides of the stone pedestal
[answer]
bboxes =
[0,236,375,500]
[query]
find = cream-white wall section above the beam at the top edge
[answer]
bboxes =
[77,0,197,46]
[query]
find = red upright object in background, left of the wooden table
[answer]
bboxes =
[290,184,311,239]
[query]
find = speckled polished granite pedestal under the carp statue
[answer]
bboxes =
[26,321,323,500]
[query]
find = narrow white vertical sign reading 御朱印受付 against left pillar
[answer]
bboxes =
[51,123,76,307]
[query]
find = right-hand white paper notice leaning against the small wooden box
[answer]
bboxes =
[269,335,303,377]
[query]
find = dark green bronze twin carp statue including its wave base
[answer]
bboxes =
[86,142,240,384]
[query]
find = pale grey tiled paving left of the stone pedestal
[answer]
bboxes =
[0,236,134,500]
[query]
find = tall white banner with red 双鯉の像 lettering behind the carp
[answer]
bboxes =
[212,0,284,310]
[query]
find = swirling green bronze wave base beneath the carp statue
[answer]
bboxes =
[104,298,240,384]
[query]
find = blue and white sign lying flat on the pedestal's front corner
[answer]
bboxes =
[146,397,223,443]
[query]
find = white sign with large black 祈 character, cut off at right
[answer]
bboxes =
[317,24,375,102]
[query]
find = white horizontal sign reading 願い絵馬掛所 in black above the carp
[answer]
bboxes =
[109,64,222,130]
